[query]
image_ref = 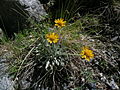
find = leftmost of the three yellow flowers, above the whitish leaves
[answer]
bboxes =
[46,33,59,43]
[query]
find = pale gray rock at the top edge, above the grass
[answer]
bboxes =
[19,0,47,21]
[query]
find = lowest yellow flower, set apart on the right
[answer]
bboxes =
[80,47,94,61]
